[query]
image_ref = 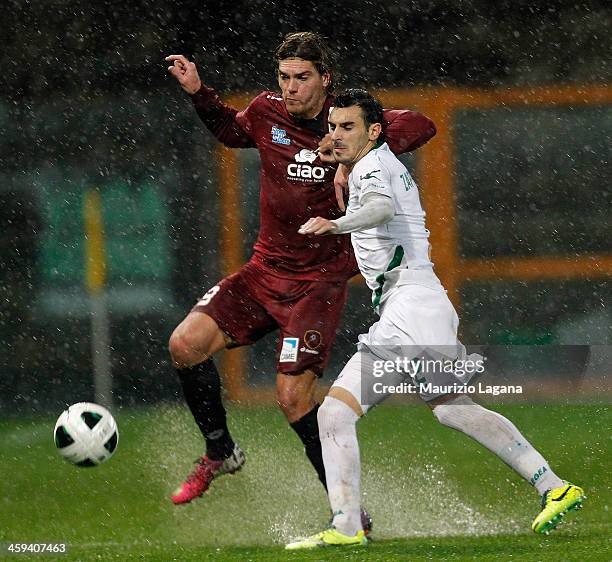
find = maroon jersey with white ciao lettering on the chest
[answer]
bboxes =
[192,86,435,281]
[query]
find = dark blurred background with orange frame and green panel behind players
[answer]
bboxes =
[0,0,612,415]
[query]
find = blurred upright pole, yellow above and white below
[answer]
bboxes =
[83,189,113,408]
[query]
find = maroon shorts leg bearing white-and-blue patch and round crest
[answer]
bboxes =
[277,282,347,377]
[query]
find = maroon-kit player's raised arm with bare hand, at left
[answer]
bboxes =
[166,55,255,148]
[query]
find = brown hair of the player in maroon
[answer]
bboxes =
[274,31,336,92]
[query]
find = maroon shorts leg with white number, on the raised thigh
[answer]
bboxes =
[192,265,278,347]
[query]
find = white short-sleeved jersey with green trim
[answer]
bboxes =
[346,143,440,308]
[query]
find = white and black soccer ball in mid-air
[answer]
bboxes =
[53,402,119,466]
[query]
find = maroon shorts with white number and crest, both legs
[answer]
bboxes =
[193,263,347,377]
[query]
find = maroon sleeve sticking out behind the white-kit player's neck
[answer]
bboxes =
[383,109,436,154]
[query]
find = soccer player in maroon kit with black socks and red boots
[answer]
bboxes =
[166,32,435,516]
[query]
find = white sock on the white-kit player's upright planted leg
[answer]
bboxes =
[317,396,361,536]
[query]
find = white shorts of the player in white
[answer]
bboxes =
[333,284,473,406]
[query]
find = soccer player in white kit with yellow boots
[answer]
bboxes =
[287,90,584,550]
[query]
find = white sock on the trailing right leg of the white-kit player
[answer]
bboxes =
[433,396,565,495]
